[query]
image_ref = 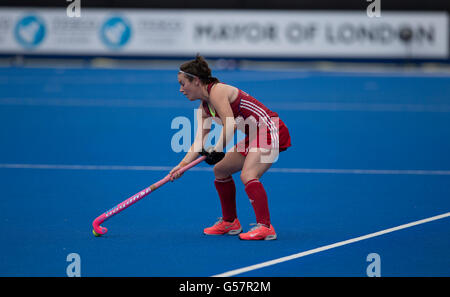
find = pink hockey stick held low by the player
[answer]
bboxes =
[92,156,206,236]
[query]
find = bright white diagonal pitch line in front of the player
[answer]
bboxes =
[213,212,450,277]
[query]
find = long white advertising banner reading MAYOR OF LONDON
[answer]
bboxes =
[0,7,449,59]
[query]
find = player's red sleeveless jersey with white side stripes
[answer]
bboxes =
[202,83,291,151]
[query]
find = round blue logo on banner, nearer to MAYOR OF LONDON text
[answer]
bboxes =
[100,16,131,49]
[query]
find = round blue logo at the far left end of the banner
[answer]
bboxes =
[14,15,46,48]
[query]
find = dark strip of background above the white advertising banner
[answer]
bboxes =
[0,0,450,11]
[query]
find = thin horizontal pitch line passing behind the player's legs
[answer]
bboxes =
[0,163,450,175]
